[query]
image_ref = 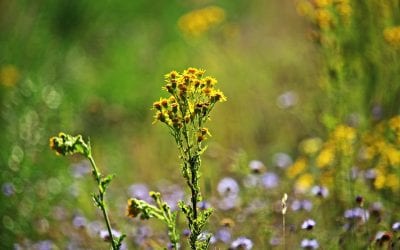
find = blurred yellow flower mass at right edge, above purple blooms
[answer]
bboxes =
[286,115,400,192]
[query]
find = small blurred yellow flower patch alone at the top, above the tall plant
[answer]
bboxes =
[178,6,225,37]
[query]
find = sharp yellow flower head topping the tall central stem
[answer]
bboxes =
[153,68,226,142]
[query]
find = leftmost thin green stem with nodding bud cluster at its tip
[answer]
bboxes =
[50,133,125,250]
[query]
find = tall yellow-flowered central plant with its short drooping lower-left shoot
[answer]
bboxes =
[128,68,226,249]
